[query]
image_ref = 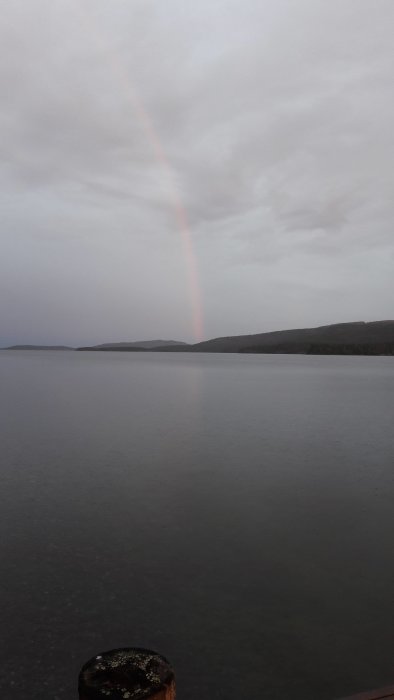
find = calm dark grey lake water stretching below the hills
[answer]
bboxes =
[0,352,394,700]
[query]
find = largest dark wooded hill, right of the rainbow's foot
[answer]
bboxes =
[184,321,394,355]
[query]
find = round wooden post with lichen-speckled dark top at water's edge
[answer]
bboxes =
[78,648,175,700]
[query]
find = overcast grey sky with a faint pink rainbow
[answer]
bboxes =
[0,0,394,345]
